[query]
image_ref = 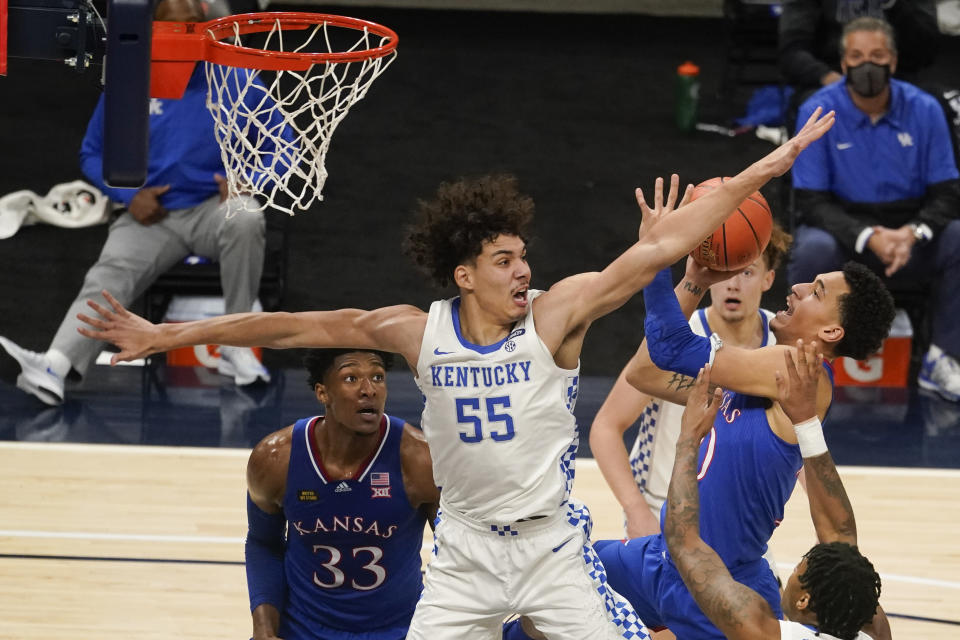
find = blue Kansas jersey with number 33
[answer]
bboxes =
[280,415,425,640]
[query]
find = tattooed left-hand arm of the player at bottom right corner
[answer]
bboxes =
[663,365,780,640]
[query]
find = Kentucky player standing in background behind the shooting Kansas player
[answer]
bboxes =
[590,224,792,536]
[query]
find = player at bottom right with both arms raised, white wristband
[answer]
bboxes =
[664,348,891,640]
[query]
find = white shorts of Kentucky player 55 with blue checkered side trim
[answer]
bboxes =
[407,503,649,640]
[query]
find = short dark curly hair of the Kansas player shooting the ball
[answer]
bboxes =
[834,261,896,360]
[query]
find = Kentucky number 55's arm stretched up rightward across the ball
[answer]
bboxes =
[536,110,834,345]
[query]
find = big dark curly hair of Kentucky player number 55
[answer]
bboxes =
[404,175,533,287]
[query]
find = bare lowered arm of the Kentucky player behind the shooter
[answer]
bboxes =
[590,372,660,538]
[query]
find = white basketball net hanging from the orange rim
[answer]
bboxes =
[205,20,396,215]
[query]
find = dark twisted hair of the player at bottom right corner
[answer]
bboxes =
[797,542,880,640]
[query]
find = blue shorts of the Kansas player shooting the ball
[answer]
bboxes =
[593,535,783,640]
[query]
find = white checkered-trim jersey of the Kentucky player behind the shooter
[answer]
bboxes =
[630,308,777,518]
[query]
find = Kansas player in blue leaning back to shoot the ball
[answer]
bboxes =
[596,244,894,640]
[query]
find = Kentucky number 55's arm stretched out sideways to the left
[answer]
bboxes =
[78,291,427,366]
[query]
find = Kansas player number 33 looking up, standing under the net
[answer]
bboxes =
[246,349,440,640]
